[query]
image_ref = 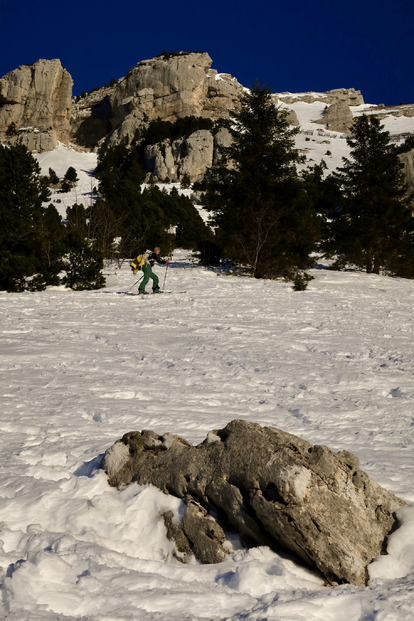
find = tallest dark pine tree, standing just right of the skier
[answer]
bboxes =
[206,85,317,278]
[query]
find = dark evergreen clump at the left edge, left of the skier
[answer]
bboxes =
[0,145,104,291]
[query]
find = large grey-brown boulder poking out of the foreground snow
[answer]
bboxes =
[102,420,405,586]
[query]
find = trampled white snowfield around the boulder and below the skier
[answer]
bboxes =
[0,251,414,621]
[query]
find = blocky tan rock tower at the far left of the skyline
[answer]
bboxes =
[0,60,73,151]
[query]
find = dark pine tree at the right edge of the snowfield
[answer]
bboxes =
[328,115,414,276]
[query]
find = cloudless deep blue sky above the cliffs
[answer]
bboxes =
[0,0,414,105]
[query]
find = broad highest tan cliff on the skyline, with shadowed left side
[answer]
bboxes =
[72,53,243,148]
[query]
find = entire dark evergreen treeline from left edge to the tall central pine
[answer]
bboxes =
[0,117,213,291]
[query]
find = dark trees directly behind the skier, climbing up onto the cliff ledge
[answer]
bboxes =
[95,117,213,257]
